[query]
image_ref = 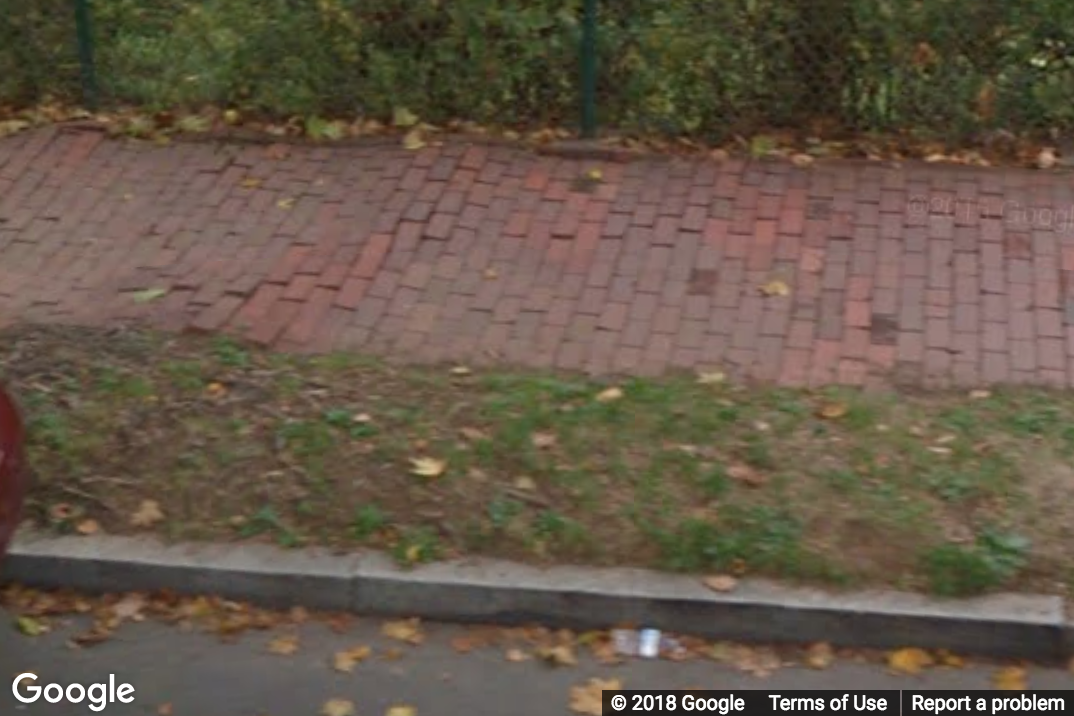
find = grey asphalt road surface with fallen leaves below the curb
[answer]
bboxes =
[0,612,1074,716]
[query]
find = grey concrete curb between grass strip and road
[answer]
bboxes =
[0,535,1074,661]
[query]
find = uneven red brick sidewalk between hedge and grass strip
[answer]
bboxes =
[0,129,1074,386]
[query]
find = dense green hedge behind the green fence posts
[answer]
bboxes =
[6,0,1074,141]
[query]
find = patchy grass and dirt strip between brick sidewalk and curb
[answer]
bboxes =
[0,324,1074,596]
